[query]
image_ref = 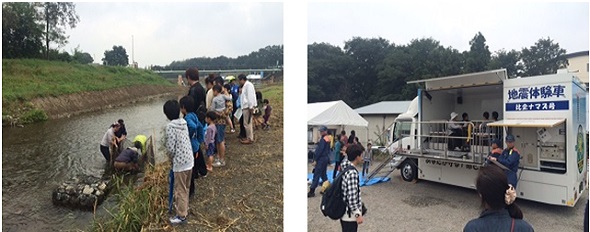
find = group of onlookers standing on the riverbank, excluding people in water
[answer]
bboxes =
[164,68,271,224]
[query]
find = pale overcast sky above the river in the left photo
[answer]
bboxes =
[61,2,283,67]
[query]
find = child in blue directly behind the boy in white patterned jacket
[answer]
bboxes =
[180,96,207,198]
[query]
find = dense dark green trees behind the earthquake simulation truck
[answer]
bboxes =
[307,32,567,108]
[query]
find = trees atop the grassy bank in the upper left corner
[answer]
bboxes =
[2,2,134,66]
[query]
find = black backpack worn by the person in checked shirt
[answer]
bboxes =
[320,165,354,220]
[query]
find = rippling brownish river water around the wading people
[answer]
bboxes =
[2,96,176,231]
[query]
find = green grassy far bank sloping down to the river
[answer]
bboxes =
[2,59,179,126]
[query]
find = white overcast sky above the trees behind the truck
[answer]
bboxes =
[308,1,590,53]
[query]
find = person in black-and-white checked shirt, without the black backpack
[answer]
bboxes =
[340,144,364,232]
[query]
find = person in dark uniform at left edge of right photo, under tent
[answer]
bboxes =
[307,126,330,197]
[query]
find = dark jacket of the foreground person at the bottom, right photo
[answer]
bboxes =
[463,209,535,232]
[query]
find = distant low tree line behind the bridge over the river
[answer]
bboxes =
[151,45,283,70]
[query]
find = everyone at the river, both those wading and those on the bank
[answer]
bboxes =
[100,68,272,224]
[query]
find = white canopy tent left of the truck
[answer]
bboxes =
[307,100,369,144]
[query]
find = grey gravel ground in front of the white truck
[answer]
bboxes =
[307,161,588,232]
